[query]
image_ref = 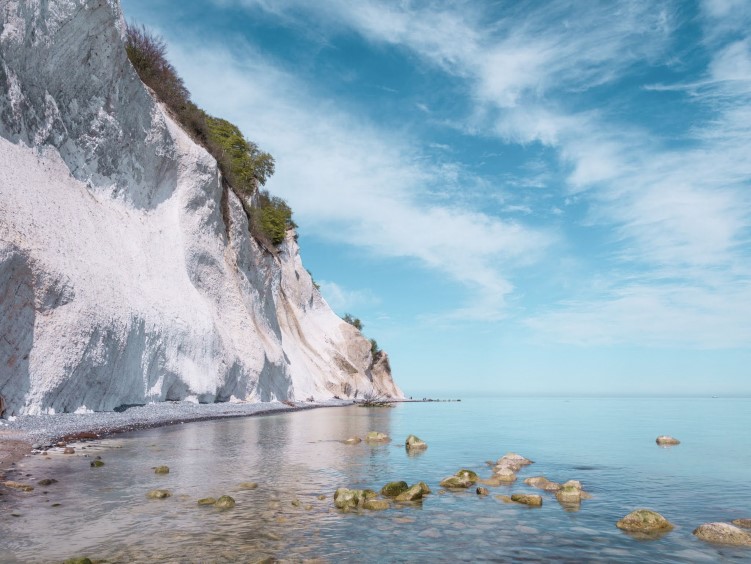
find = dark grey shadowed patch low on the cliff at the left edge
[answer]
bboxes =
[0,246,36,418]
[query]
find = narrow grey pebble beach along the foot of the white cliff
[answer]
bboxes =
[0,399,358,472]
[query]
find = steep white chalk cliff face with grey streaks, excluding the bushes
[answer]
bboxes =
[0,0,402,416]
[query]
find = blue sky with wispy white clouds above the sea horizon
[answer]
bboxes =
[122,0,751,397]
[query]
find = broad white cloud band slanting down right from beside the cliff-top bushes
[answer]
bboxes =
[170,41,550,318]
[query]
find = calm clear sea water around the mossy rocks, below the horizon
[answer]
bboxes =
[0,398,751,562]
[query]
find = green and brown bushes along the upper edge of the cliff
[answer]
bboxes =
[125,25,296,246]
